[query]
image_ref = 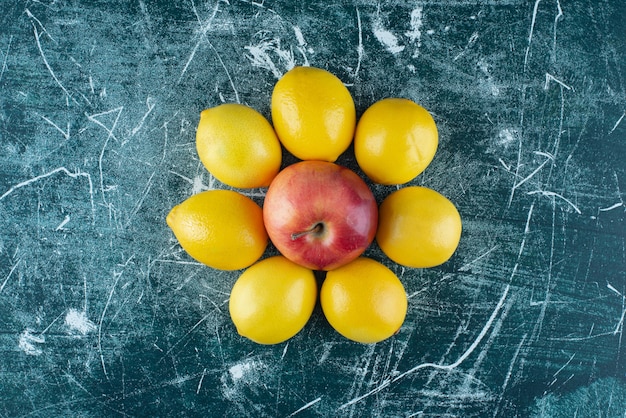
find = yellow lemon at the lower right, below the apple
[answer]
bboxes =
[320,257,407,344]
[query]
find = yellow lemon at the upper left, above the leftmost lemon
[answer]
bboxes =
[196,103,282,188]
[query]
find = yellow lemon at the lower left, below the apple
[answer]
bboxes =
[228,256,317,344]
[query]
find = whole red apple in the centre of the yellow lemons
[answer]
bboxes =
[263,161,378,270]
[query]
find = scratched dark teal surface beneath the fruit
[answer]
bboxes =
[0,0,626,418]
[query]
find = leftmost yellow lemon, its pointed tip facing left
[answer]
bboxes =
[166,190,268,270]
